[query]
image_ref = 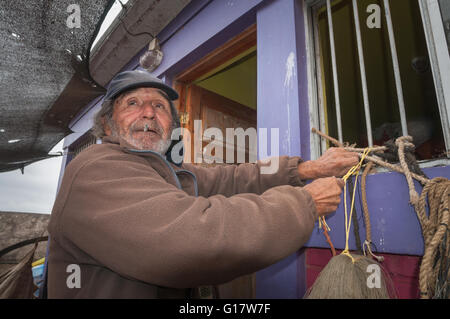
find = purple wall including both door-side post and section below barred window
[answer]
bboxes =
[256,0,450,298]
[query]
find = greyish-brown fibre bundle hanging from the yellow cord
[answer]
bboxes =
[305,254,395,299]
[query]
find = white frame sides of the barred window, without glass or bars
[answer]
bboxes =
[303,0,450,162]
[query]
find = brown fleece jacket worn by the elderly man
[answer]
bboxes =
[48,139,317,298]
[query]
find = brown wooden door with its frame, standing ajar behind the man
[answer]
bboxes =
[174,25,257,298]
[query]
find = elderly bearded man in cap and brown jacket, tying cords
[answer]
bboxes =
[48,71,358,298]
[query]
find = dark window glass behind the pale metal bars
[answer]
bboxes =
[318,0,445,159]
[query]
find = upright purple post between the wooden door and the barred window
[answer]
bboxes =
[256,0,309,298]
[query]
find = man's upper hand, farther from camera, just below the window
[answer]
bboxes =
[298,147,359,179]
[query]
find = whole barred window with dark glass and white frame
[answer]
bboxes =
[307,0,450,160]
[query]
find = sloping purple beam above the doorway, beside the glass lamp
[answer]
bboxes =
[123,0,263,81]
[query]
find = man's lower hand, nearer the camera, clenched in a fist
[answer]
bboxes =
[303,177,344,217]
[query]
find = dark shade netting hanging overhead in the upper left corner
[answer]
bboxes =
[0,0,114,172]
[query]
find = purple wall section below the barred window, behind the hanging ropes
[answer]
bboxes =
[307,167,450,256]
